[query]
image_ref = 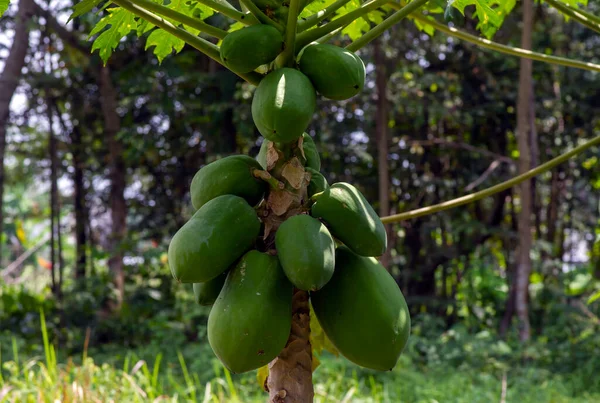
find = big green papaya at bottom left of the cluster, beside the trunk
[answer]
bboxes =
[208,250,293,373]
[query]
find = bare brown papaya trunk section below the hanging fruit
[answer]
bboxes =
[267,289,314,403]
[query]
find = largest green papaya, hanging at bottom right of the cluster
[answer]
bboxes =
[310,246,410,371]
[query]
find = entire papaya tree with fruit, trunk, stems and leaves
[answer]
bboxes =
[0,0,600,402]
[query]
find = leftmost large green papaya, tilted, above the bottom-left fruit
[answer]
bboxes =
[168,195,260,283]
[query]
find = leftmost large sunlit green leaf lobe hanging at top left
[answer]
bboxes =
[90,7,137,63]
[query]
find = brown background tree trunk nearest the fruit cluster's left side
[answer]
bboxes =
[99,67,127,310]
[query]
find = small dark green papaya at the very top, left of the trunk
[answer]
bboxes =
[220,24,283,73]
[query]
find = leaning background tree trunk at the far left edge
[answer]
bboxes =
[0,0,32,267]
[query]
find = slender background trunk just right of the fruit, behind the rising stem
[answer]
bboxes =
[374,39,392,270]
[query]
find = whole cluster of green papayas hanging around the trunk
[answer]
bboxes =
[168,15,410,373]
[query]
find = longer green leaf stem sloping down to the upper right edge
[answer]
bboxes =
[410,12,600,72]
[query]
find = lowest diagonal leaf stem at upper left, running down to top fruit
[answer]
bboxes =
[111,0,262,85]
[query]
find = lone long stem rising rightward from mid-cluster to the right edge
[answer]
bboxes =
[380,136,600,224]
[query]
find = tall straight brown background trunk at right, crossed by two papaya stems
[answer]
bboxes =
[515,0,534,341]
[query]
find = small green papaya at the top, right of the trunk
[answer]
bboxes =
[298,42,365,100]
